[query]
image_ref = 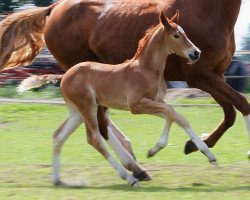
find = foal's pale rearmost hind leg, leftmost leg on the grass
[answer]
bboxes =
[52,107,82,185]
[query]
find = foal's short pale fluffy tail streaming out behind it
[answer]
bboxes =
[17,74,63,93]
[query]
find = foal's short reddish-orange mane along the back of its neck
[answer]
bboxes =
[134,23,162,59]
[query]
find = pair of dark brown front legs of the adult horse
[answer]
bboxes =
[185,71,250,154]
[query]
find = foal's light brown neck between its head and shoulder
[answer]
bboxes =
[135,25,169,74]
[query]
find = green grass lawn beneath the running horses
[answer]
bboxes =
[0,104,250,200]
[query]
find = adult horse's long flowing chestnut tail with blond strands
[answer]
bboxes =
[0,3,57,71]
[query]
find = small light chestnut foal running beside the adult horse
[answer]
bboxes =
[19,12,216,186]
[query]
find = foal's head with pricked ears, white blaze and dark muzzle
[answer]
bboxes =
[160,11,201,63]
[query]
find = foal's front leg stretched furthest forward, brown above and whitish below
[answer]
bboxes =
[130,98,216,164]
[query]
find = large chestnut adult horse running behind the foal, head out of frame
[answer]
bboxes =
[0,0,247,157]
